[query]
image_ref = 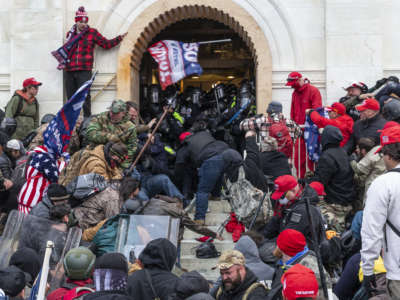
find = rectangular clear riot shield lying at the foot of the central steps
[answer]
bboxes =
[115,215,179,262]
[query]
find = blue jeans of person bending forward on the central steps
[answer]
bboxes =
[194,154,225,220]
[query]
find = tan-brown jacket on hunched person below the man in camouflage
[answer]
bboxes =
[79,145,122,181]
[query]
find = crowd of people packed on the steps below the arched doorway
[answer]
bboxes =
[0,7,400,300]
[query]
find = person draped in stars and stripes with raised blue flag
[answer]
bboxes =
[18,75,95,214]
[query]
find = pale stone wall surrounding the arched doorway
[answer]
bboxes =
[0,0,400,115]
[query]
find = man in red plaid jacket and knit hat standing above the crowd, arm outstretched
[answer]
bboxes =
[65,6,126,117]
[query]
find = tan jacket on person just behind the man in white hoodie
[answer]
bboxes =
[351,145,386,201]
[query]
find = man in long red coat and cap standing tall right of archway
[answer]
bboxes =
[286,72,322,178]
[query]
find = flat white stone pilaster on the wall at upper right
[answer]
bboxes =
[325,0,384,103]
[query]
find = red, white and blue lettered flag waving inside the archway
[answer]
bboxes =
[148,40,203,90]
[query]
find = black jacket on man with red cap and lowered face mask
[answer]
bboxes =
[264,187,324,249]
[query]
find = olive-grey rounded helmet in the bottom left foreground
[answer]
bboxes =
[64,247,96,280]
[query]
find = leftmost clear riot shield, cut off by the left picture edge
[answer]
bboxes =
[0,210,26,269]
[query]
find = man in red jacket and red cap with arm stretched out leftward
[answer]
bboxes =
[306,102,354,147]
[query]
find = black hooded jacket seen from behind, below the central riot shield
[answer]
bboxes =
[127,238,180,300]
